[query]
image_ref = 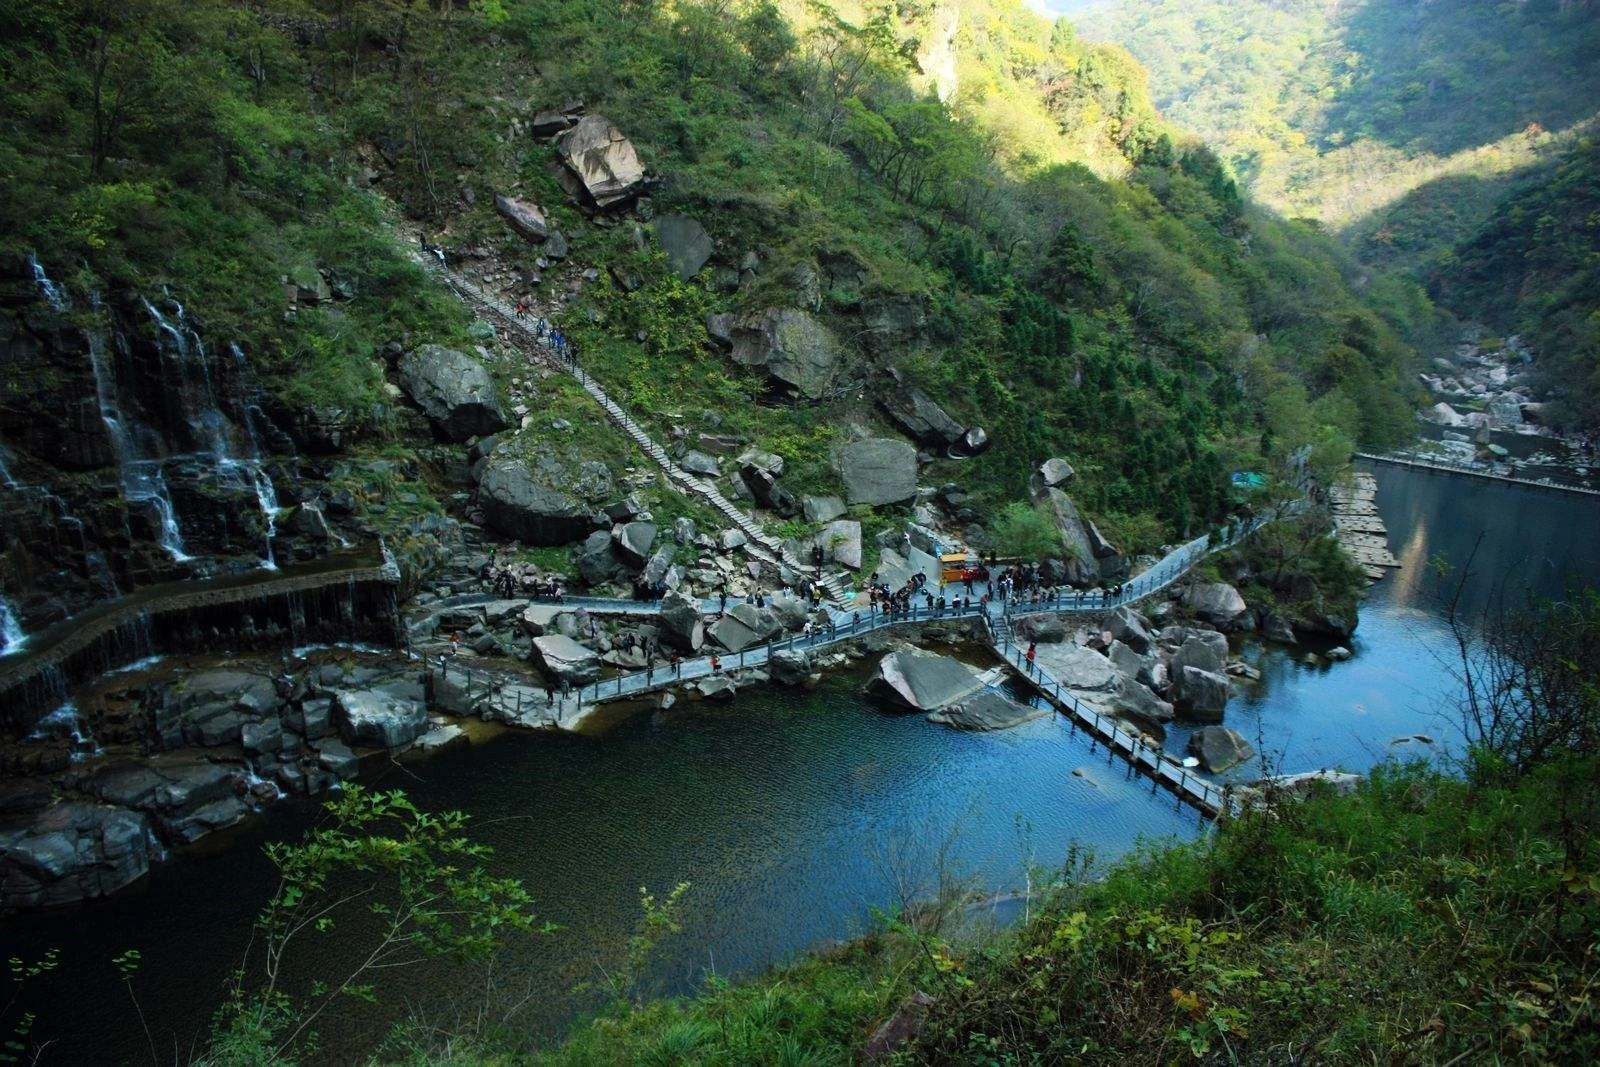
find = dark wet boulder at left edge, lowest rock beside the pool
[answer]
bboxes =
[0,801,157,910]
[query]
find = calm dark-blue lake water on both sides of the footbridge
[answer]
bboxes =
[12,467,1600,1064]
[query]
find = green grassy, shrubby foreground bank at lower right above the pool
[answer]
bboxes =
[531,768,1600,1065]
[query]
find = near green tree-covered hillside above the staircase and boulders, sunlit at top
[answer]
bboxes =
[0,0,1429,566]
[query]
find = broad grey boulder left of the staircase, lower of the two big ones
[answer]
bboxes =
[478,450,614,545]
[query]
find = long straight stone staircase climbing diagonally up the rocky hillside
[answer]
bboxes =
[418,253,851,600]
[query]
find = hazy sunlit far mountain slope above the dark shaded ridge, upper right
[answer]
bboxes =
[1082,0,1600,237]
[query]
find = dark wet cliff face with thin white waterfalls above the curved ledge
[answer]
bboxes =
[0,259,350,630]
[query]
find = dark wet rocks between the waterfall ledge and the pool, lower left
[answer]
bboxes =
[0,659,454,910]
